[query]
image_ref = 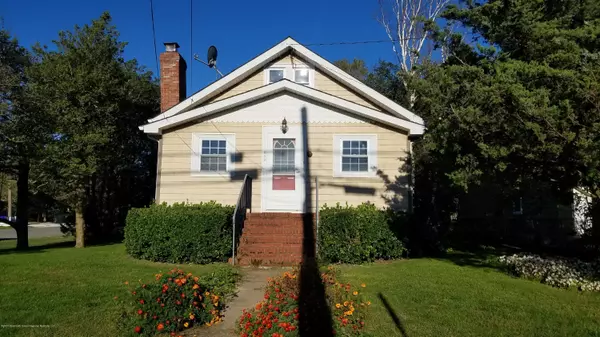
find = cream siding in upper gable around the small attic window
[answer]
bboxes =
[207,54,383,111]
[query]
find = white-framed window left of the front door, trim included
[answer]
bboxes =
[191,133,235,176]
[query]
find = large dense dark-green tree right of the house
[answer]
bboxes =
[411,0,600,237]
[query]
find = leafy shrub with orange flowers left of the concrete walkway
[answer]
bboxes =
[117,268,238,336]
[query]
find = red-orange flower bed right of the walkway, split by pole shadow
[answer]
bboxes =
[238,268,371,337]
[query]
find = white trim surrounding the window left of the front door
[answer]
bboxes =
[190,133,236,177]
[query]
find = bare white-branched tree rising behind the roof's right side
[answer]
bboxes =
[378,0,451,73]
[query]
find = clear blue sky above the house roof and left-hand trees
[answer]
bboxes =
[0,0,394,94]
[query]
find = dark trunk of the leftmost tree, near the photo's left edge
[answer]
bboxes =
[15,160,29,249]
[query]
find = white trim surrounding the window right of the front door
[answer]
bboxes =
[333,134,378,178]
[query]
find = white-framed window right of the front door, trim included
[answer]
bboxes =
[333,135,377,177]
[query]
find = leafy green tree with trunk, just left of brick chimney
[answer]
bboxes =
[28,13,158,247]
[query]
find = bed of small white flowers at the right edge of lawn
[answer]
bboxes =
[499,254,600,291]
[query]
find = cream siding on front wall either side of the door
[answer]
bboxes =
[157,122,408,212]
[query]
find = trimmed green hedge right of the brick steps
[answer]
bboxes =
[319,204,405,263]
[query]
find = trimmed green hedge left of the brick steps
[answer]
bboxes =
[125,202,234,263]
